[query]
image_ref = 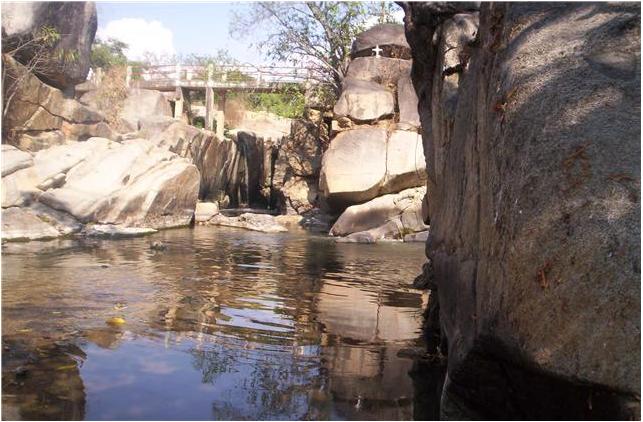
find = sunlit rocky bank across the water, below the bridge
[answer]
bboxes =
[2,9,427,242]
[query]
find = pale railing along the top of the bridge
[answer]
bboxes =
[126,64,311,88]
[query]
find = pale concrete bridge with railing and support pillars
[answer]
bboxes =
[125,64,317,138]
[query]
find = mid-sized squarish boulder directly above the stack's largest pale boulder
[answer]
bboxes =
[333,78,395,121]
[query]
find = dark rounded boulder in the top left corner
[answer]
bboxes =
[2,2,97,90]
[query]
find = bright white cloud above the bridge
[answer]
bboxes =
[96,18,176,60]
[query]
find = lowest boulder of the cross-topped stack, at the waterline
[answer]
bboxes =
[330,187,427,240]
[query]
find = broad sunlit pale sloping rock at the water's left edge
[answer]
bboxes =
[2,138,200,240]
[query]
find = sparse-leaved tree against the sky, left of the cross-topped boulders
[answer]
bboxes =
[230,1,402,102]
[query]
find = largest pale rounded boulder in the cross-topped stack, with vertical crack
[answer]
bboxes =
[319,127,426,211]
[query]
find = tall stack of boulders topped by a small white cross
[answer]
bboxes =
[319,24,427,242]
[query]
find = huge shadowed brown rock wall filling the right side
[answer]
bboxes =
[403,3,641,419]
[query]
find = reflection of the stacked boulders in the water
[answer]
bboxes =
[316,274,423,419]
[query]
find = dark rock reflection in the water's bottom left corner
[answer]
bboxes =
[2,337,85,420]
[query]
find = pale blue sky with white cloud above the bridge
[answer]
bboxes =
[96,2,263,63]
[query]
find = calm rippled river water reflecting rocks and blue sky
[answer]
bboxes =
[2,227,440,420]
